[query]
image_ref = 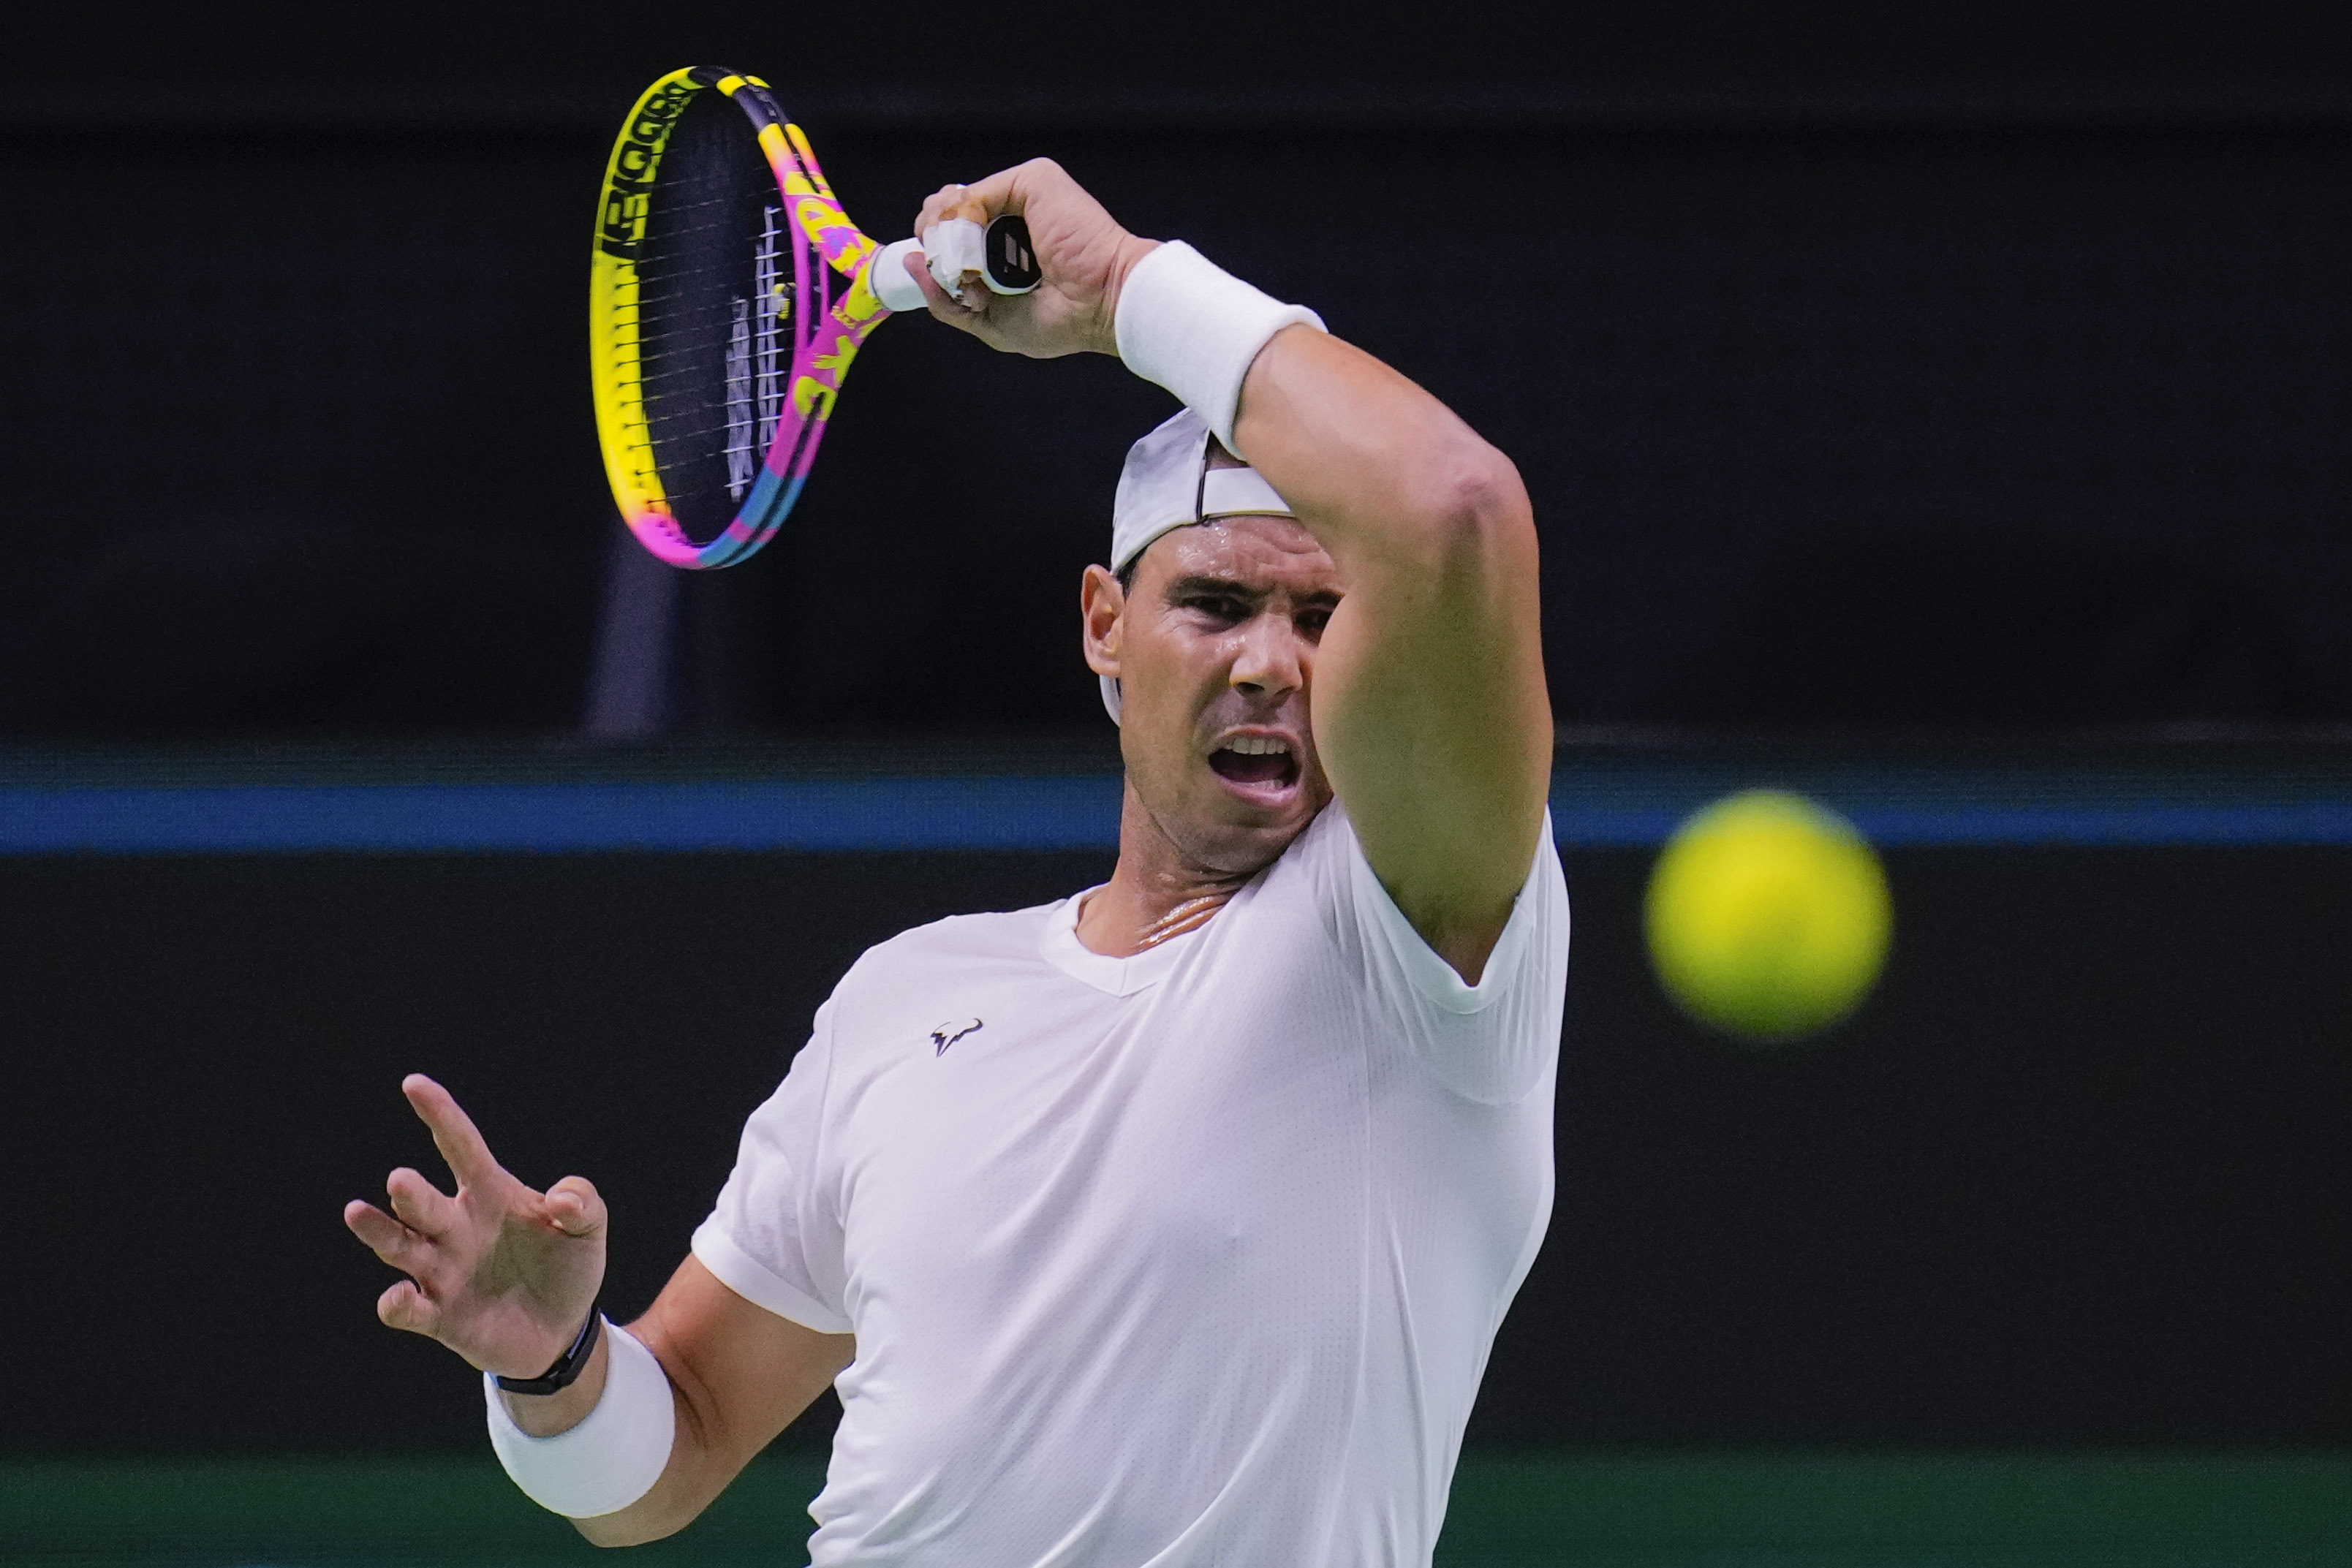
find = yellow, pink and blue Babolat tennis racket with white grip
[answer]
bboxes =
[588,66,1040,567]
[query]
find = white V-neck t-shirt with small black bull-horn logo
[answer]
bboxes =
[694,804,1569,1568]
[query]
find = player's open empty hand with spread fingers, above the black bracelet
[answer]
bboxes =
[344,1072,605,1378]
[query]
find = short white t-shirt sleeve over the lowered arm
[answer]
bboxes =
[694,1001,852,1333]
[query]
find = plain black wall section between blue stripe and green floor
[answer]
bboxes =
[0,849,2352,1450]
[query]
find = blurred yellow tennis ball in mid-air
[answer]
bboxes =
[1644,790,1894,1044]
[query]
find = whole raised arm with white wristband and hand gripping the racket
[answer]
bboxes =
[918,160,1552,978]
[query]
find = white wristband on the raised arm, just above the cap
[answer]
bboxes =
[1113,240,1324,456]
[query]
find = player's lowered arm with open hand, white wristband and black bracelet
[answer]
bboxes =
[344,1075,854,1547]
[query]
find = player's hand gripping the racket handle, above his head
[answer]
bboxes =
[908,157,1160,360]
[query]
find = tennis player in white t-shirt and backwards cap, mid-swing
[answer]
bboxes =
[346,162,1569,1568]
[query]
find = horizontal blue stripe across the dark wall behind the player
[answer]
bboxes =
[0,776,2352,856]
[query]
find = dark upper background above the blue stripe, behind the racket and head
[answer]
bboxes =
[13,2,2352,738]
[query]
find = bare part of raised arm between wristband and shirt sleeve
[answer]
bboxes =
[1235,327,1552,976]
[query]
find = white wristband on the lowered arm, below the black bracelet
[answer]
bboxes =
[482,1319,677,1518]
